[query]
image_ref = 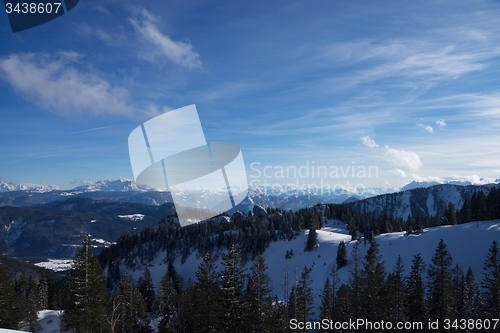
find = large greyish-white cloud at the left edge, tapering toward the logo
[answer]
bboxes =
[0,52,168,119]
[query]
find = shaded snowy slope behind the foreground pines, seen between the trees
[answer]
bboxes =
[122,220,500,305]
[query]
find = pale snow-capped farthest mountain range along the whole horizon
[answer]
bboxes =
[0,179,500,206]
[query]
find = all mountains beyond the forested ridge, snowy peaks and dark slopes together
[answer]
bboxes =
[0,180,498,258]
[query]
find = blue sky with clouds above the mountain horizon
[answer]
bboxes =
[0,0,500,188]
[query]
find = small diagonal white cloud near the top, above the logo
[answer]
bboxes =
[129,8,201,68]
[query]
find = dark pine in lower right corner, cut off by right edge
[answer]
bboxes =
[481,241,500,318]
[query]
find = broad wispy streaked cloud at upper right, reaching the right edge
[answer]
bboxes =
[308,38,500,90]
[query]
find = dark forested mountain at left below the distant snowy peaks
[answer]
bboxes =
[0,198,175,258]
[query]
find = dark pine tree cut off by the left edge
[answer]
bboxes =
[0,250,20,329]
